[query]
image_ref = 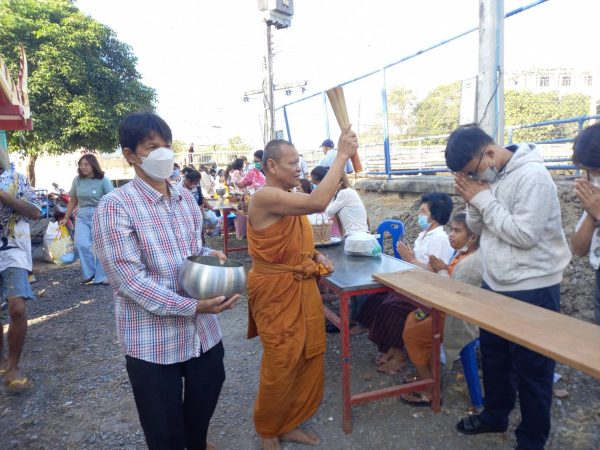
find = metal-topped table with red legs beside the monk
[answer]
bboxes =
[319,244,442,434]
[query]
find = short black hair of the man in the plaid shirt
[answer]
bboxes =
[119,112,173,153]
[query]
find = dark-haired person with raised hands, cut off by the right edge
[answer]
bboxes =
[571,123,600,325]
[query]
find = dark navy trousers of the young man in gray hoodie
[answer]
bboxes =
[480,283,560,450]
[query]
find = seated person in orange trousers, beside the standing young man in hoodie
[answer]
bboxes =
[401,213,483,406]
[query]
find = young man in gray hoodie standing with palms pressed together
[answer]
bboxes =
[446,126,571,450]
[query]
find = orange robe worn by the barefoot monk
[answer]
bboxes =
[247,216,325,438]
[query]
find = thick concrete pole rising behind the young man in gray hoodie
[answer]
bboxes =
[477,0,504,145]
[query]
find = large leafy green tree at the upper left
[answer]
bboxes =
[0,0,156,184]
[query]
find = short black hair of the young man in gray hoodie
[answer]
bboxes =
[444,125,494,172]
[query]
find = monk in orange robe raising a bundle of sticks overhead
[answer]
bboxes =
[247,128,358,450]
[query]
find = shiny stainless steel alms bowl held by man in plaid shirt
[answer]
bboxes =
[179,256,246,299]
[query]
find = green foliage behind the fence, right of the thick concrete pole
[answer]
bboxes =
[504,90,590,142]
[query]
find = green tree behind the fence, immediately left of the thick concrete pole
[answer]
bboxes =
[411,81,461,144]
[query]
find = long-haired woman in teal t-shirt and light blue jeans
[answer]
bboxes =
[59,154,113,285]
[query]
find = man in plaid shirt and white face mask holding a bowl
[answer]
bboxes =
[93,113,239,449]
